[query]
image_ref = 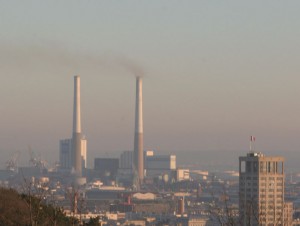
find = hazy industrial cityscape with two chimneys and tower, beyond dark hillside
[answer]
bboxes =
[0,76,300,225]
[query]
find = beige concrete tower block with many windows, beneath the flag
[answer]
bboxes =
[239,152,292,226]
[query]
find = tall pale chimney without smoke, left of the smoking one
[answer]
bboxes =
[72,75,82,177]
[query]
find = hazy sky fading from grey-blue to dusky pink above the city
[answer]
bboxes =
[0,0,300,170]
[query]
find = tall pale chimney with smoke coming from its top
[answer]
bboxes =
[134,77,144,186]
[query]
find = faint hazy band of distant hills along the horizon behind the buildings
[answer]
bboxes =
[0,147,300,173]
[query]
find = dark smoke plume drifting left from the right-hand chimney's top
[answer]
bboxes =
[0,43,144,78]
